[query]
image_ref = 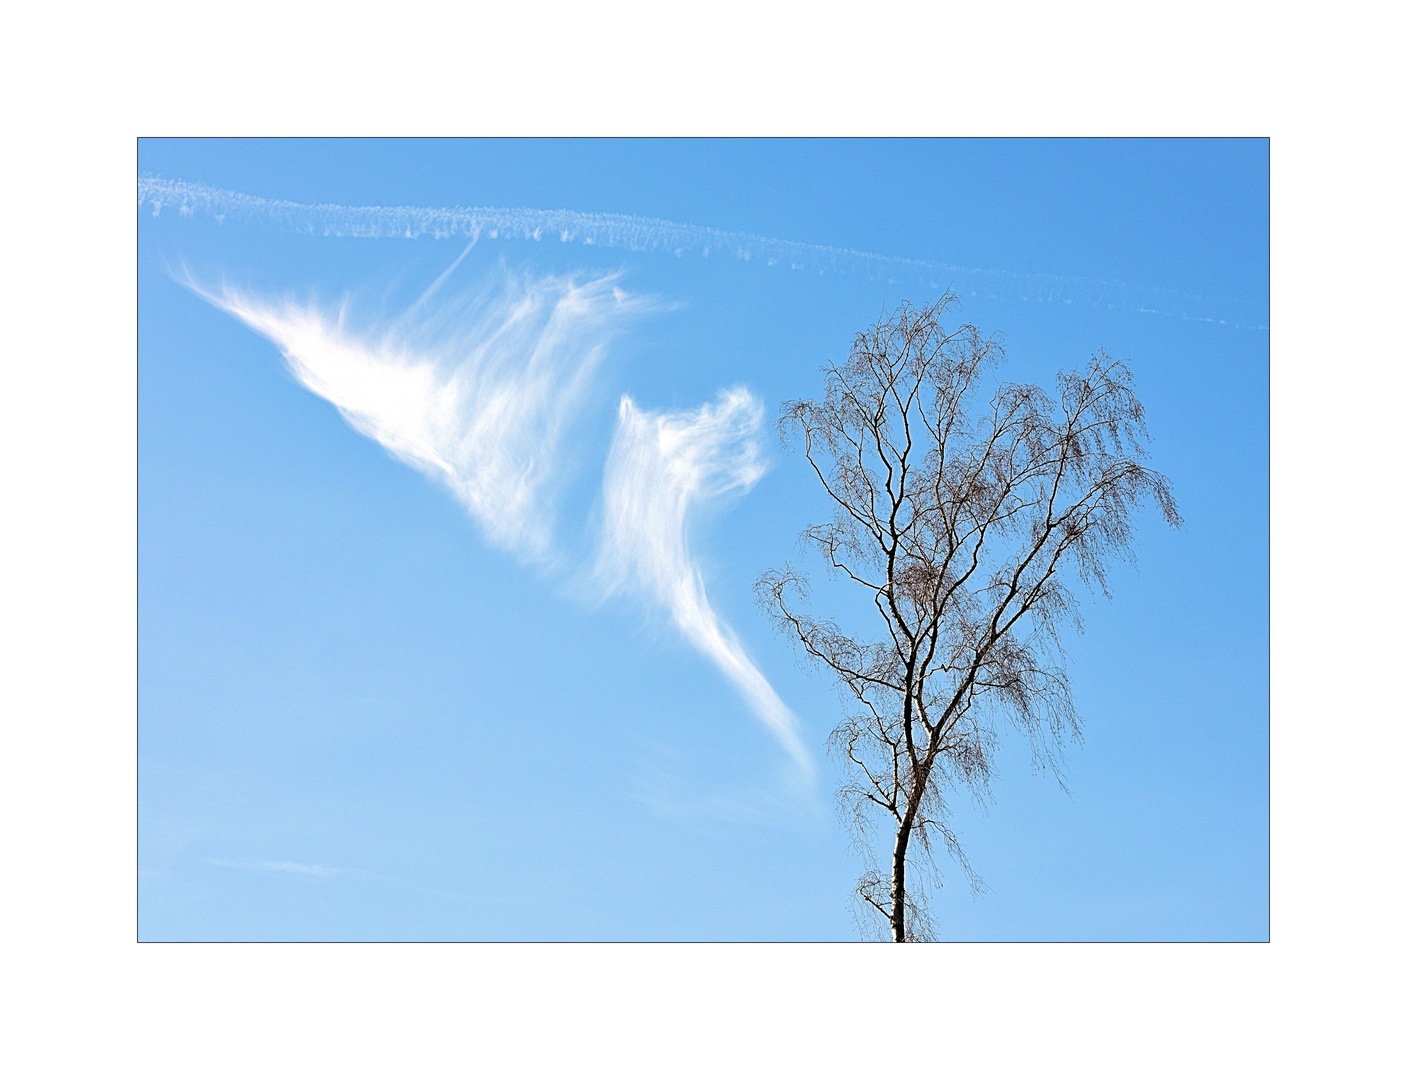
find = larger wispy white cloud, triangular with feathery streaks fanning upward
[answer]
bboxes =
[187,267,647,563]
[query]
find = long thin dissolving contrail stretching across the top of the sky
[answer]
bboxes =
[136,176,1269,329]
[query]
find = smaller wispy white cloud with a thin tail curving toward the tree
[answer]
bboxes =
[594,387,810,773]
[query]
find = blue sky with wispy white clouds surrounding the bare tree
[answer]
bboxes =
[138,141,1269,939]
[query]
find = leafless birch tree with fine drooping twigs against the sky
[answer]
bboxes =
[757,294,1180,941]
